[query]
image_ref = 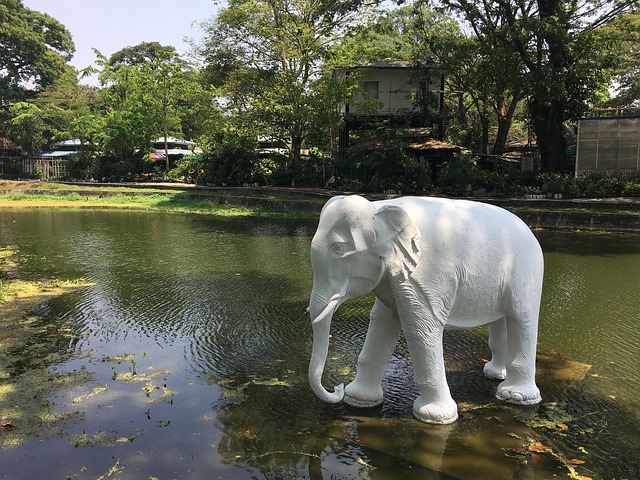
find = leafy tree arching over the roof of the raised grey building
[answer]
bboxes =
[340,2,522,154]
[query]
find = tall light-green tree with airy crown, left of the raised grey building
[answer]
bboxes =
[202,0,376,182]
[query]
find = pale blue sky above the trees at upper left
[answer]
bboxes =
[22,0,219,79]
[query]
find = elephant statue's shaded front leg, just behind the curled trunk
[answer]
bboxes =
[344,298,400,407]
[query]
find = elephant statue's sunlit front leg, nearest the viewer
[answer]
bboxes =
[405,321,458,425]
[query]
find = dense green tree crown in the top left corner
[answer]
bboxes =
[0,0,75,105]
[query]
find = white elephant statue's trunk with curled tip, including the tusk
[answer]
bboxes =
[309,295,344,403]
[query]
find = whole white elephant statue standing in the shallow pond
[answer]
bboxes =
[309,196,543,423]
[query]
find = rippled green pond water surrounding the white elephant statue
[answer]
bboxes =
[0,209,640,480]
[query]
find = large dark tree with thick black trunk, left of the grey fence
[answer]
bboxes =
[441,0,638,171]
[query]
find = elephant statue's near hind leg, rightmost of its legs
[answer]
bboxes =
[496,312,541,405]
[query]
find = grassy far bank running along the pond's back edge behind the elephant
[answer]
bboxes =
[0,181,640,233]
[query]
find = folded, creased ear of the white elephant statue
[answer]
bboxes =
[375,205,420,282]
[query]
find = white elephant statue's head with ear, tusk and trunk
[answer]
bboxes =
[309,195,420,403]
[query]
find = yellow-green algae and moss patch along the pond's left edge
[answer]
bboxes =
[0,247,92,449]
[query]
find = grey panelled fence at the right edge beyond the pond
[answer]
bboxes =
[576,117,640,179]
